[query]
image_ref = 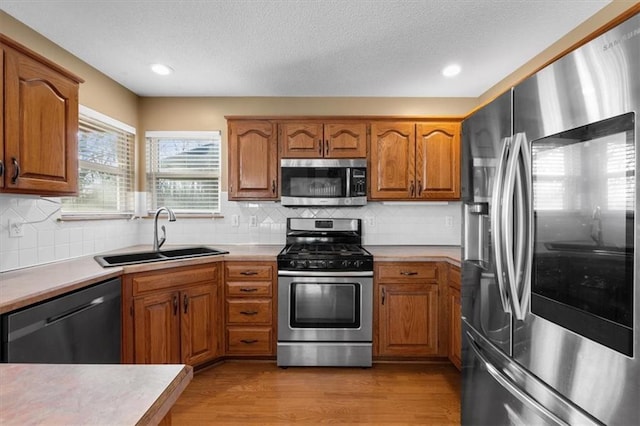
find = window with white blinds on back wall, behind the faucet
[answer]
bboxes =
[146,131,220,214]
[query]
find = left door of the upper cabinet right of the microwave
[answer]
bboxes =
[369,122,416,200]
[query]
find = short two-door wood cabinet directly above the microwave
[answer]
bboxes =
[279,121,367,158]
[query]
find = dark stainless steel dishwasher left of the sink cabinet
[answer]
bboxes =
[2,278,122,364]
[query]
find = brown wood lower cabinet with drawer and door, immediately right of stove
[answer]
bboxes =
[374,262,443,358]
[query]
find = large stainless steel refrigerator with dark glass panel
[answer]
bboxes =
[461,15,640,425]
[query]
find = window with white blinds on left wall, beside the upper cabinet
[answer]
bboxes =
[62,105,135,217]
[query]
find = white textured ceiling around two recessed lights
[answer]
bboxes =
[0,0,610,97]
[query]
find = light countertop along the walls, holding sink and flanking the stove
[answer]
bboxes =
[0,244,460,314]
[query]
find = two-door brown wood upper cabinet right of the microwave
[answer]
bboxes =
[369,122,460,200]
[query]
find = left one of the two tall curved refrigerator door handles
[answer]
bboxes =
[490,138,511,313]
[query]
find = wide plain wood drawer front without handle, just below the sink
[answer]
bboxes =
[131,264,219,296]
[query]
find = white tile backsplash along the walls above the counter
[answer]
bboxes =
[0,192,461,271]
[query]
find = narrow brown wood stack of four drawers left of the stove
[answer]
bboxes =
[225,262,277,357]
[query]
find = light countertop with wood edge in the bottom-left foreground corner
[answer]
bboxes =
[0,364,193,425]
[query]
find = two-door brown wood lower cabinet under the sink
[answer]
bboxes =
[123,263,222,365]
